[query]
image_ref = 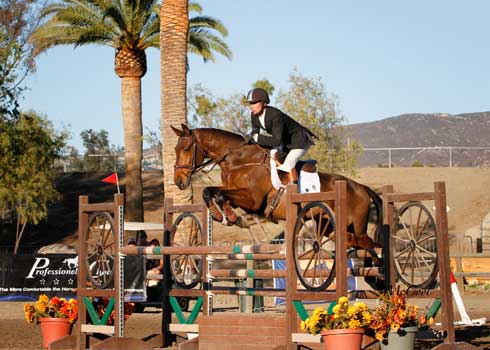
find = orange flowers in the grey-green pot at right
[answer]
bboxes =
[369,288,434,350]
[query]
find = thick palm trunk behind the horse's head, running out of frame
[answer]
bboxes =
[160,0,192,204]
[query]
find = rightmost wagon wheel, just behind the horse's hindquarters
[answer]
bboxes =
[391,202,438,288]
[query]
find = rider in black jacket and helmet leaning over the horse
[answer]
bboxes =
[245,88,317,183]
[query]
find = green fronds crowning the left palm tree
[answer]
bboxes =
[31,0,232,62]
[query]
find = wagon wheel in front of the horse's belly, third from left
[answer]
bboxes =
[293,202,335,291]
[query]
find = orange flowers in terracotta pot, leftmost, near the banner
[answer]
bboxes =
[24,294,78,348]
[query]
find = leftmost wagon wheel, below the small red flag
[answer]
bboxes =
[84,212,116,289]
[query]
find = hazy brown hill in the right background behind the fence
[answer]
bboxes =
[348,112,490,166]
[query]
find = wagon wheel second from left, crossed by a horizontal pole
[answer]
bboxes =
[170,213,202,289]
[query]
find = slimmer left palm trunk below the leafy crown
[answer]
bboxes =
[121,77,144,221]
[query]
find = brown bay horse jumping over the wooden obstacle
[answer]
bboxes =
[171,124,382,250]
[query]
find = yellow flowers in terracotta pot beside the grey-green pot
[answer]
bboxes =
[301,297,371,350]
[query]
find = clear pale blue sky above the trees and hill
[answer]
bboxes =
[22,0,490,151]
